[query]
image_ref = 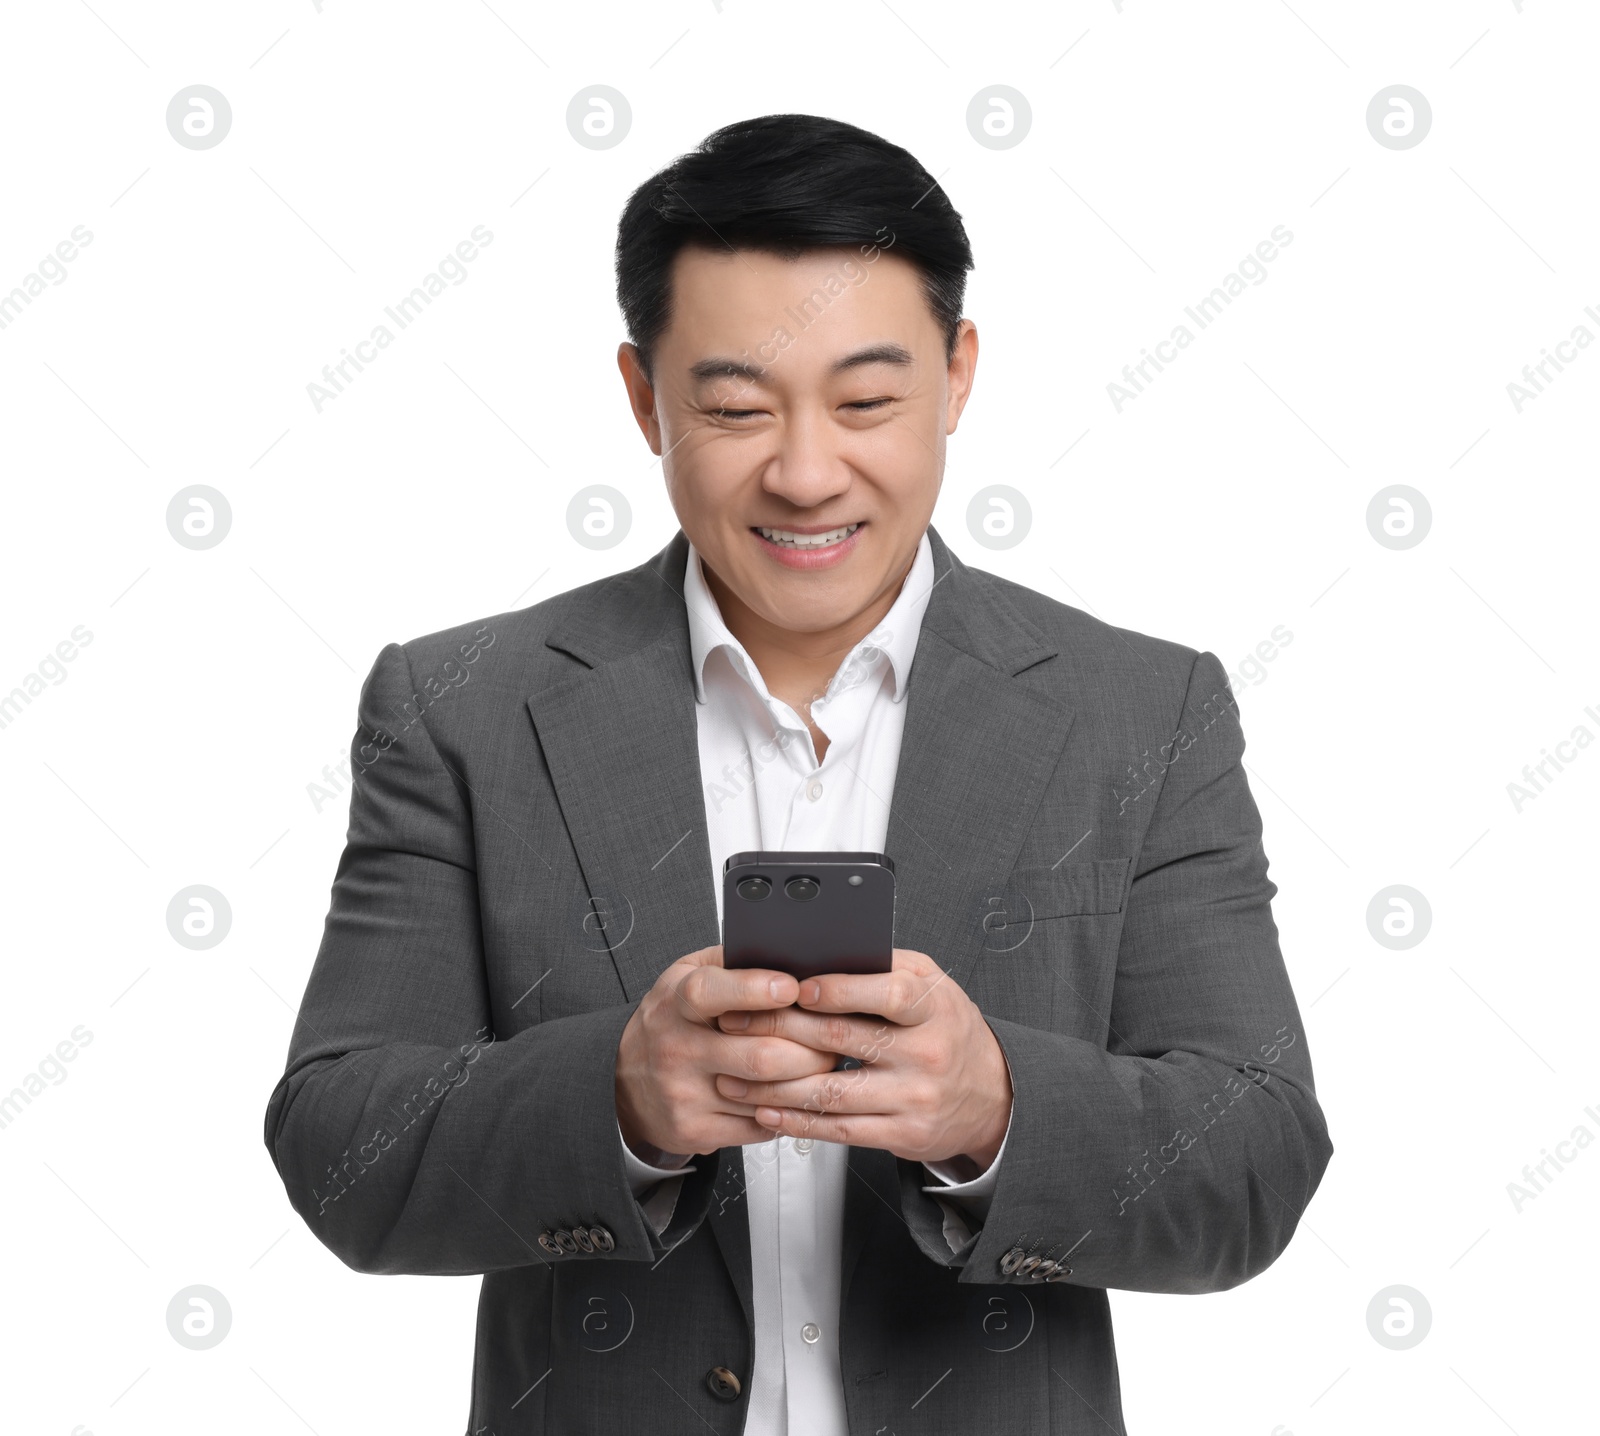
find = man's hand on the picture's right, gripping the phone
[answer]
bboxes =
[717,948,1011,1177]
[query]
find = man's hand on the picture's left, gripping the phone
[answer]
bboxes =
[616,945,834,1159]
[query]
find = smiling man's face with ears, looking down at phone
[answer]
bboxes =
[618,246,978,633]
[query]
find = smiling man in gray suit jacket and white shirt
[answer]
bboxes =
[266,115,1331,1436]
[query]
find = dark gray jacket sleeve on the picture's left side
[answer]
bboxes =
[264,644,714,1274]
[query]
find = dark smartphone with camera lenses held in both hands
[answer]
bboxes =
[722,852,894,982]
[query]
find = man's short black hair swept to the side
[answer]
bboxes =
[616,115,973,376]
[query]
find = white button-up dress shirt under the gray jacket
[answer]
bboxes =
[618,534,1010,1436]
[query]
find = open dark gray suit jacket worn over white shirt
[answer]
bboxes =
[266,531,1333,1436]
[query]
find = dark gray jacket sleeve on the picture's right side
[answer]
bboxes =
[901,652,1333,1292]
